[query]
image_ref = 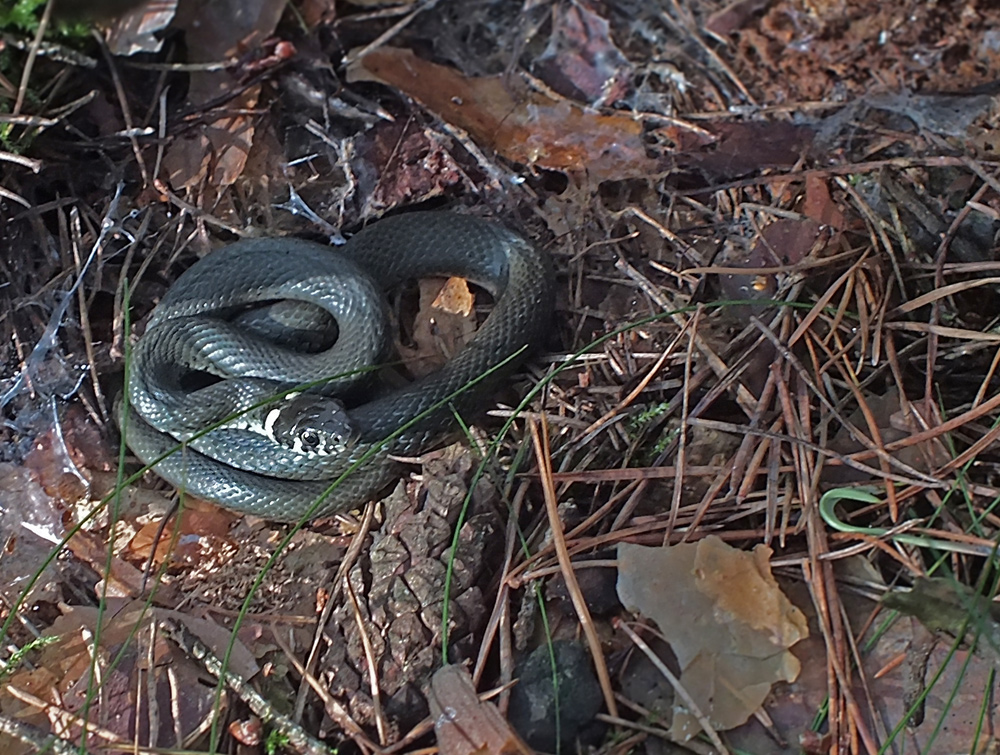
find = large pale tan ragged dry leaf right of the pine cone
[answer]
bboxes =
[618,535,809,741]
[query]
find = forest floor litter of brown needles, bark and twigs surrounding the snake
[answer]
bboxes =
[0,0,1000,753]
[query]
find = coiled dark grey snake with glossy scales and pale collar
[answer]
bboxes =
[124,212,554,521]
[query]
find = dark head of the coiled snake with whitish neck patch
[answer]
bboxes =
[264,393,359,455]
